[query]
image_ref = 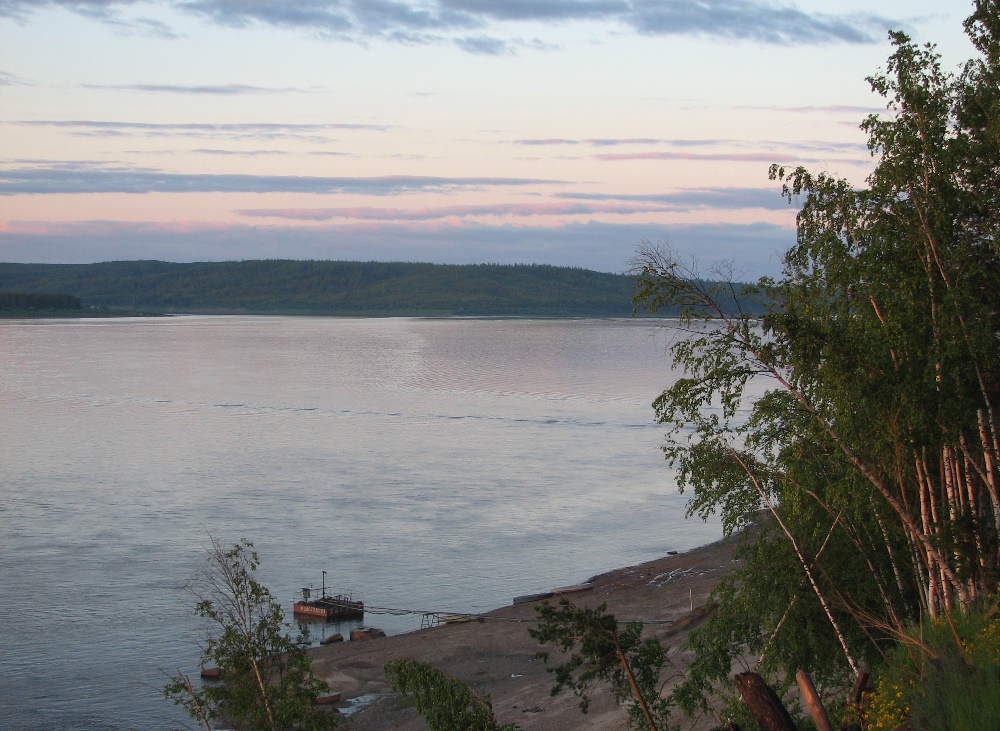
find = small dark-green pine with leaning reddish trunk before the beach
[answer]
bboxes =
[528,598,671,729]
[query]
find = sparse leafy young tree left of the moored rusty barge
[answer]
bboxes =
[163,539,342,731]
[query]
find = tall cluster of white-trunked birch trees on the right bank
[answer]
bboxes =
[636,0,1000,711]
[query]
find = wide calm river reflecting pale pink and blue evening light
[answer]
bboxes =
[0,317,721,731]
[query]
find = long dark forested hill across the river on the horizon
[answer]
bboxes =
[0,260,660,317]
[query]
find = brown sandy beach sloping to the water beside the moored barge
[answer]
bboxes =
[310,537,739,731]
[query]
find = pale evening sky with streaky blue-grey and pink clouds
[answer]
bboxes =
[0,0,973,278]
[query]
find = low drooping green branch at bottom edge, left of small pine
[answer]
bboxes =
[384,658,517,731]
